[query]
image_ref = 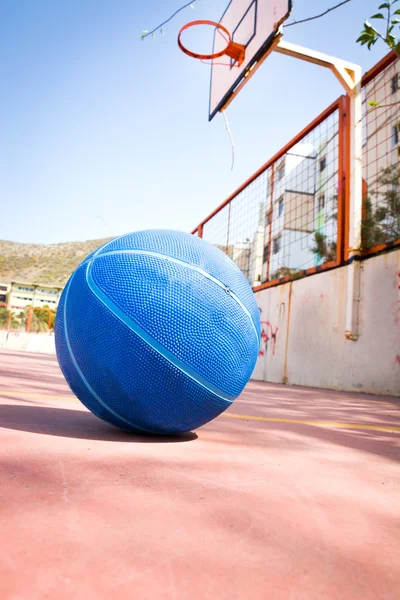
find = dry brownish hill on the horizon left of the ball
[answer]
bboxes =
[0,238,110,286]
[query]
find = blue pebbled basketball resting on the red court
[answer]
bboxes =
[55,230,260,434]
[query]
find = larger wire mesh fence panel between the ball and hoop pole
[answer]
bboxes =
[202,103,339,286]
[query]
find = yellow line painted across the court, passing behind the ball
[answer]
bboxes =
[0,391,400,431]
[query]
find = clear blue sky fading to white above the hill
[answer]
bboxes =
[0,0,386,243]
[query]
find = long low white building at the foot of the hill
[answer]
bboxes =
[8,281,63,309]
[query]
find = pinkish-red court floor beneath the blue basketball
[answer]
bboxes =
[0,350,400,600]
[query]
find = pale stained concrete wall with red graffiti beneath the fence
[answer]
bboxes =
[253,250,400,395]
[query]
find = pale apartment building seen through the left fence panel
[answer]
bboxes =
[254,131,338,281]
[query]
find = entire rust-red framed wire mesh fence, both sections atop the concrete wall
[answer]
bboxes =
[196,54,400,287]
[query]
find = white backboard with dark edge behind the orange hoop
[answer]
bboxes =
[209,0,292,121]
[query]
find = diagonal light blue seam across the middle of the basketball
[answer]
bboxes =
[86,261,236,404]
